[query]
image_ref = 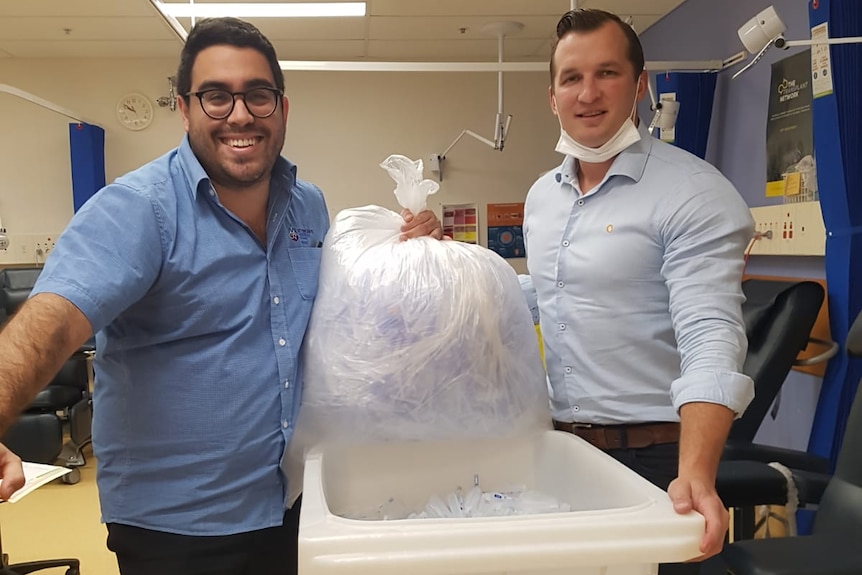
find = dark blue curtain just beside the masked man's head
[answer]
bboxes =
[655,72,717,158]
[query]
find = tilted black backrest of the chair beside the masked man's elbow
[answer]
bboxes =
[728,279,824,443]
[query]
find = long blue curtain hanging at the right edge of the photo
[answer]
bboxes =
[808,0,862,468]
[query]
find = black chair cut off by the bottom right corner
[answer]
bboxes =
[720,308,862,575]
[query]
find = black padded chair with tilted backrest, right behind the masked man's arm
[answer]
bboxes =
[716,279,834,539]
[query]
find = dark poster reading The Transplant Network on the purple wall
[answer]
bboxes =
[766,50,817,202]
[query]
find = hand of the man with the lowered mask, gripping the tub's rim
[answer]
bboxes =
[667,477,730,561]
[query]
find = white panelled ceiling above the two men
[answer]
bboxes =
[0,0,684,62]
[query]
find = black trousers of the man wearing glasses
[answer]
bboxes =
[107,500,300,575]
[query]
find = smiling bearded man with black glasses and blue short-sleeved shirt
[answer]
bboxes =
[0,18,442,575]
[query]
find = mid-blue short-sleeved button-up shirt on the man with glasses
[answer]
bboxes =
[33,135,329,535]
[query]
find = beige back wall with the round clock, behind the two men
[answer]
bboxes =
[0,59,559,271]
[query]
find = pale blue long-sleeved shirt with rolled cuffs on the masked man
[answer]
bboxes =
[524,125,754,424]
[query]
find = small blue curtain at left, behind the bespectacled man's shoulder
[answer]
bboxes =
[69,123,105,212]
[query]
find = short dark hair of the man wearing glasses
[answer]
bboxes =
[177,18,284,103]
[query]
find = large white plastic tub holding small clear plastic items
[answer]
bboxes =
[299,431,704,575]
